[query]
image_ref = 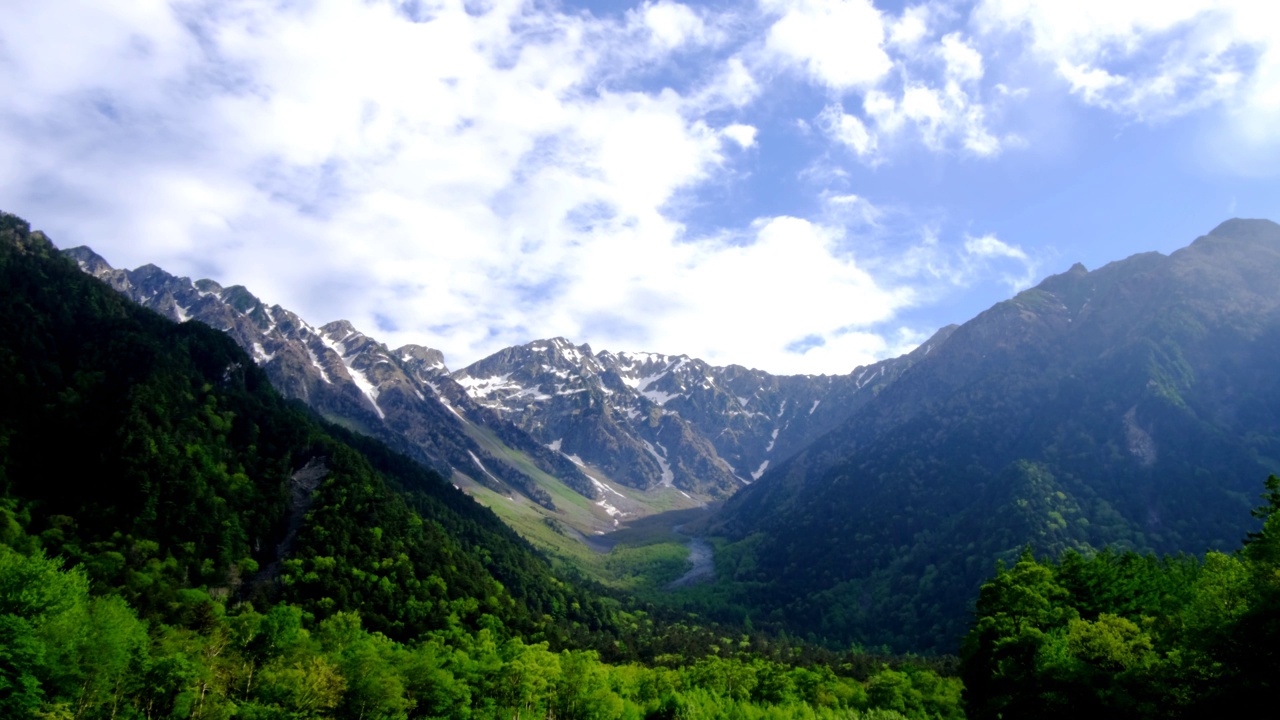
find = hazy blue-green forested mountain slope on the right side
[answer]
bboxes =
[717,220,1280,648]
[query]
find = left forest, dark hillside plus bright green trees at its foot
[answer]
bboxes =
[0,215,961,719]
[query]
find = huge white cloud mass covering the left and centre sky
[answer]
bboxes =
[0,0,962,372]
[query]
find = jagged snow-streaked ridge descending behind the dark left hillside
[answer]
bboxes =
[64,247,600,507]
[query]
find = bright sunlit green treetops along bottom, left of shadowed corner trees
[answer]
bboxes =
[0,538,963,720]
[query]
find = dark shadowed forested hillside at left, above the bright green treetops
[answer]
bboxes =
[0,210,607,638]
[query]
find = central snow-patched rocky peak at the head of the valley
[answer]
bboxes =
[453,328,952,497]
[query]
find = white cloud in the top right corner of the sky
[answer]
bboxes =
[973,0,1280,176]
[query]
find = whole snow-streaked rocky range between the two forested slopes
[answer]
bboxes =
[64,240,952,530]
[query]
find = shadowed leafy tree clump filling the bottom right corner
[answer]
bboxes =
[961,475,1280,719]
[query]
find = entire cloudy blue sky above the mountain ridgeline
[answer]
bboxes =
[0,0,1280,373]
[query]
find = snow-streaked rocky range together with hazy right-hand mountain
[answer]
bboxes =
[65,213,1280,650]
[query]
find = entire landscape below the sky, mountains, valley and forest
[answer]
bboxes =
[0,210,1280,719]
